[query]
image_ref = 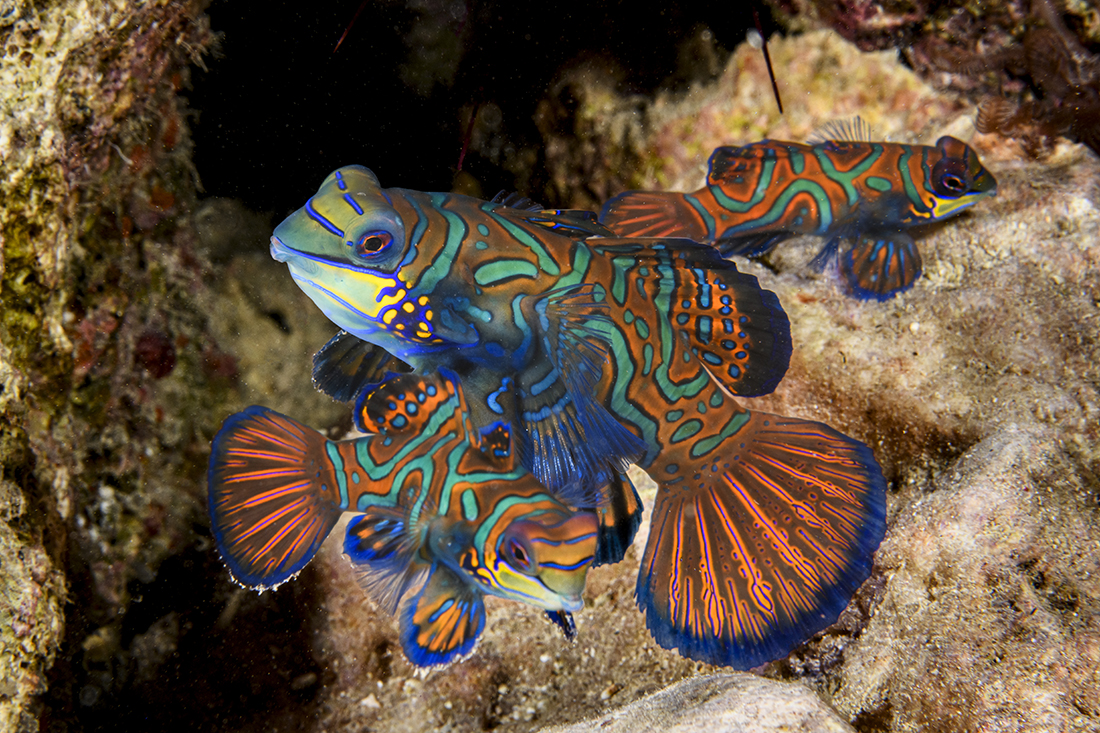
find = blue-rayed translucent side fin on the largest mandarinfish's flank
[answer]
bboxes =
[518,284,645,505]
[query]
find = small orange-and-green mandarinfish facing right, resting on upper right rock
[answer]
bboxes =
[600,118,997,300]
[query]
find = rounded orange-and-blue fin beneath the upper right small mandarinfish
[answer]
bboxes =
[840,231,921,300]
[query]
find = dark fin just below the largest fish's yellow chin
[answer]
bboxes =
[314,331,413,402]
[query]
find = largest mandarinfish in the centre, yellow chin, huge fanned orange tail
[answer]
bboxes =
[272,165,886,668]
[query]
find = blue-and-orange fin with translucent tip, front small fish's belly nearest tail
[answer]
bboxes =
[344,506,426,614]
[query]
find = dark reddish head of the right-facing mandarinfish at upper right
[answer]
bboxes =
[922,135,997,220]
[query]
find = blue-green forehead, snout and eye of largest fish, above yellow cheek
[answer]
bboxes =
[272,165,406,273]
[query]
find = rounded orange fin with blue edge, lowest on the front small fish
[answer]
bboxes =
[400,561,485,667]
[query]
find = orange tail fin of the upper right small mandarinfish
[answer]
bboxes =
[600,190,713,242]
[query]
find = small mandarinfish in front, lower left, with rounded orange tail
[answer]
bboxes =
[209,372,602,666]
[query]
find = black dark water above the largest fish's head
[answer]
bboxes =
[188,0,777,218]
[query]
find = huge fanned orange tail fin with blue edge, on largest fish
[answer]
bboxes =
[636,413,886,669]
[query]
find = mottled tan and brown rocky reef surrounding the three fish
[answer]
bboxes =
[0,5,1100,733]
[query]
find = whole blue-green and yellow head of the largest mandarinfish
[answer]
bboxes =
[271,165,422,352]
